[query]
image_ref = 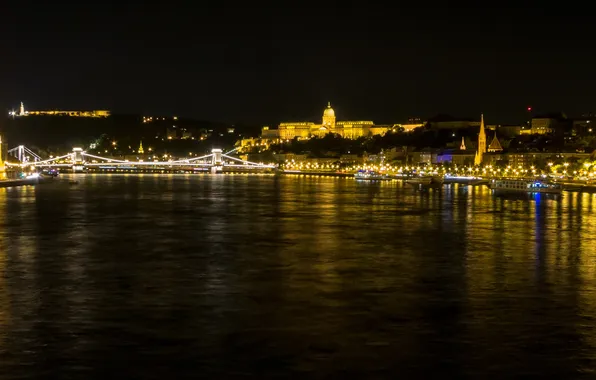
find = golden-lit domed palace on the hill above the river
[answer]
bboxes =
[261,103,391,140]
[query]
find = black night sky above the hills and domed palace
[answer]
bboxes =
[0,0,596,123]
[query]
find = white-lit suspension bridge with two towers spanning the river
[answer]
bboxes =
[7,145,276,173]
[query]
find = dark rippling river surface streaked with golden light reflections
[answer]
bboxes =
[0,175,596,379]
